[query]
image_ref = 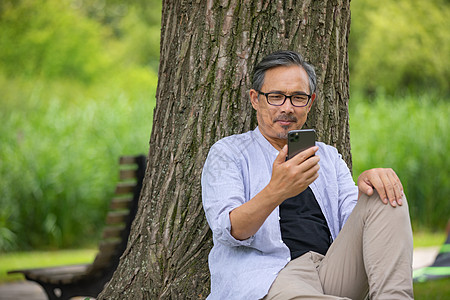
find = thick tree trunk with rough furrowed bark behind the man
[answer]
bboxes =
[99,0,351,299]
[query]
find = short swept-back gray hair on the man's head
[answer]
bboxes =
[252,50,317,95]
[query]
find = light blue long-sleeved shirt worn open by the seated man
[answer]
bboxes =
[202,128,358,300]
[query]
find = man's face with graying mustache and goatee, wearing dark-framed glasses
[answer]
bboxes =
[250,66,316,149]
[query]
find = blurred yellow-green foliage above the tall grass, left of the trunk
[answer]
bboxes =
[0,0,161,83]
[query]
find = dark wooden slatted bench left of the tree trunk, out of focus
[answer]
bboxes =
[8,155,146,300]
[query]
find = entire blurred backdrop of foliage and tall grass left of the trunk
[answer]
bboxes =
[0,0,161,251]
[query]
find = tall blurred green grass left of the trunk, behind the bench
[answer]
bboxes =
[0,73,156,251]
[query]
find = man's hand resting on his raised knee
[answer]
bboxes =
[358,168,403,207]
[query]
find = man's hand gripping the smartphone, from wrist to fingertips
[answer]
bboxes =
[266,145,320,204]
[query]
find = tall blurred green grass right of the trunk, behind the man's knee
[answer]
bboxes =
[350,95,450,230]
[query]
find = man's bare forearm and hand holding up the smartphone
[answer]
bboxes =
[230,146,320,240]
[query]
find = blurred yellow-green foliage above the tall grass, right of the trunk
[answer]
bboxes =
[349,0,450,95]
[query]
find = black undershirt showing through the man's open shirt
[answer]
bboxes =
[280,187,331,259]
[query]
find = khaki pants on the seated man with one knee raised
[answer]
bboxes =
[264,193,414,300]
